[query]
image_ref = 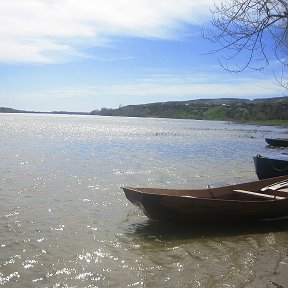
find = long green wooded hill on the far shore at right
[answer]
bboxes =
[90,97,288,123]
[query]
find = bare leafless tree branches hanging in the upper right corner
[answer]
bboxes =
[203,0,288,89]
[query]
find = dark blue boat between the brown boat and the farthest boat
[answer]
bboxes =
[253,155,288,179]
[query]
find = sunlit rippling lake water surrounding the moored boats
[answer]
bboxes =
[0,114,288,288]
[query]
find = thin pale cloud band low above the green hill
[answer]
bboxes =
[101,75,283,103]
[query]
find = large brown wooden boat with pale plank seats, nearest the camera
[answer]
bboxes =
[122,176,288,223]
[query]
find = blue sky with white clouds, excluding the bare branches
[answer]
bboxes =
[0,0,284,112]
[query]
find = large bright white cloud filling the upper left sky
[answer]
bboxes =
[0,0,213,63]
